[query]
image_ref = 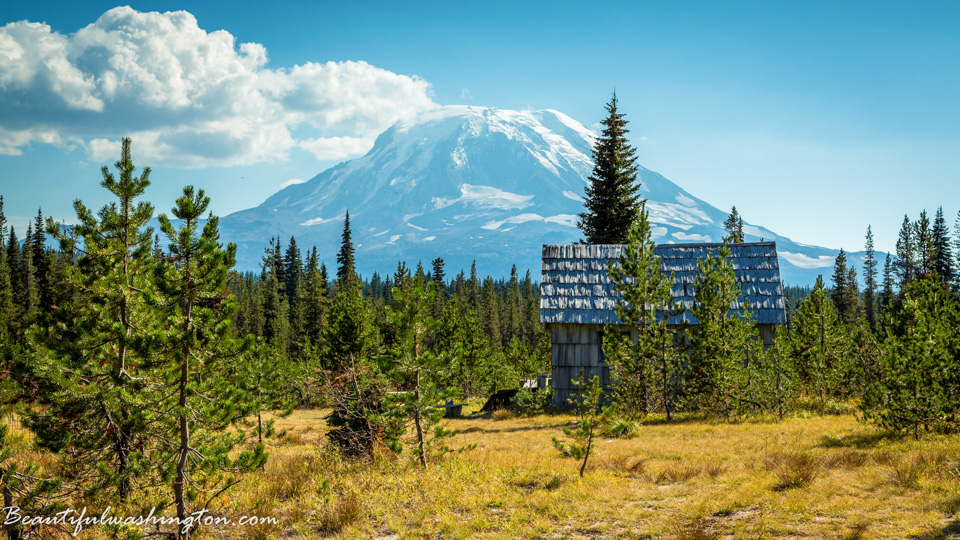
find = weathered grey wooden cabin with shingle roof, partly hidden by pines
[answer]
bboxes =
[540,242,787,406]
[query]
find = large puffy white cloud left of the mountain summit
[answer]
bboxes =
[0,7,435,167]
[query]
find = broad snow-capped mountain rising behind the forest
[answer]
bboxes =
[221,106,860,284]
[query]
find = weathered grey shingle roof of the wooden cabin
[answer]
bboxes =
[540,242,787,324]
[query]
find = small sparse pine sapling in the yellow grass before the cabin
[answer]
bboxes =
[553,373,617,477]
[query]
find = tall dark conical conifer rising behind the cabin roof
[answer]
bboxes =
[577,92,642,244]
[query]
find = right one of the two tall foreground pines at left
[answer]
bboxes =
[155,186,266,539]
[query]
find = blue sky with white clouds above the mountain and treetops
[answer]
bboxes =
[0,1,960,256]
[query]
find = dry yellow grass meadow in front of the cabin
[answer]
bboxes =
[7,406,960,540]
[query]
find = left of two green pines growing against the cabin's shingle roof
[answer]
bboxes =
[603,204,683,420]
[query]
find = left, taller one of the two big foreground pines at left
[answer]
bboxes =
[28,138,156,500]
